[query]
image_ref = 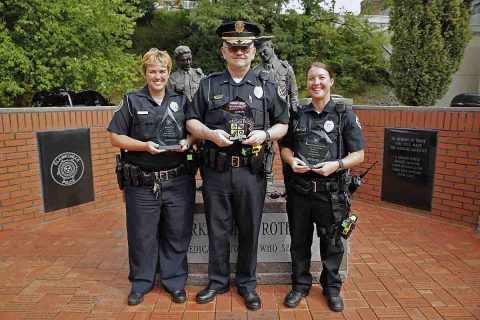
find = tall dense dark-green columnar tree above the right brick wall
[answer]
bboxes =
[390,0,471,106]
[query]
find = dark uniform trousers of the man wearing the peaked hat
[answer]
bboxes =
[202,166,266,292]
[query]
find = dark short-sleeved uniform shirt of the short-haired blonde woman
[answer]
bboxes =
[107,86,187,171]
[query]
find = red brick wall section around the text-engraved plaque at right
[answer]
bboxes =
[354,106,480,227]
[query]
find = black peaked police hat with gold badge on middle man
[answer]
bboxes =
[216,21,261,47]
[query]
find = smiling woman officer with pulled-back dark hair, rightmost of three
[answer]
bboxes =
[281,62,364,312]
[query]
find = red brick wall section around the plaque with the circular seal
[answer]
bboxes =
[0,107,122,230]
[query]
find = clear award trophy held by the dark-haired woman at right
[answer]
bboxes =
[296,130,332,169]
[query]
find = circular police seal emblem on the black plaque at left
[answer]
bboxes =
[50,152,85,187]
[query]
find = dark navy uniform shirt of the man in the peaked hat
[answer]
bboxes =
[186,69,288,155]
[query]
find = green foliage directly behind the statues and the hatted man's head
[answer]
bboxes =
[134,0,387,95]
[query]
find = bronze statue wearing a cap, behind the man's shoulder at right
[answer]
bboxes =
[254,36,298,111]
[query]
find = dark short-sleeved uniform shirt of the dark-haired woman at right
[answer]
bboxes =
[280,100,365,176]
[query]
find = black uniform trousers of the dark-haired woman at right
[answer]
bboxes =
[287,186,347,293]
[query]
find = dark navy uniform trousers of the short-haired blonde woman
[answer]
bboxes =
[125,174,195,292]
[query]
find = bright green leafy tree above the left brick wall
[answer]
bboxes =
[0,0,140,107]
